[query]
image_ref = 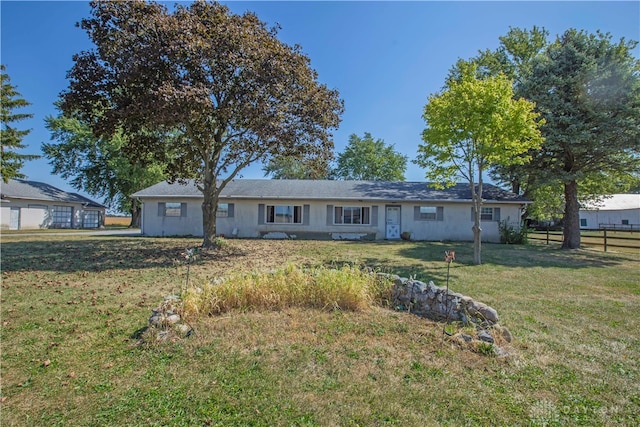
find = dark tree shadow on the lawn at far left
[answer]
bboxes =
[2,236,243,272]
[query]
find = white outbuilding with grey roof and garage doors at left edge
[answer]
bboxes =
[0,179,106,230]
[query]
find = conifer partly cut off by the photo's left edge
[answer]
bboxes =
[0,65,39,182]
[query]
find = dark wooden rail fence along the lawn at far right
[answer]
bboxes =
[528,228,640,253]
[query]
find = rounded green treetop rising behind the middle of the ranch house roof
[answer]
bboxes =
[332,132,407,181]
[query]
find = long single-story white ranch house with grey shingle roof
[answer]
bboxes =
[132,179,530,242]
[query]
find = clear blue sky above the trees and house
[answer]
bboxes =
[0,0,640,204]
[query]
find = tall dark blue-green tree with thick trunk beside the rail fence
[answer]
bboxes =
[519,29,640,249]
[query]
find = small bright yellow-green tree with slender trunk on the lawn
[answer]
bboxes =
[416,63,542,264]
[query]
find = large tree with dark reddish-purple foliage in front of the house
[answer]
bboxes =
[61,1,343,247]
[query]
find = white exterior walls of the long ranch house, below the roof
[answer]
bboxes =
[142,198,521,242]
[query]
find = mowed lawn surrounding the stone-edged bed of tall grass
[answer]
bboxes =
[0,235,640,426]
